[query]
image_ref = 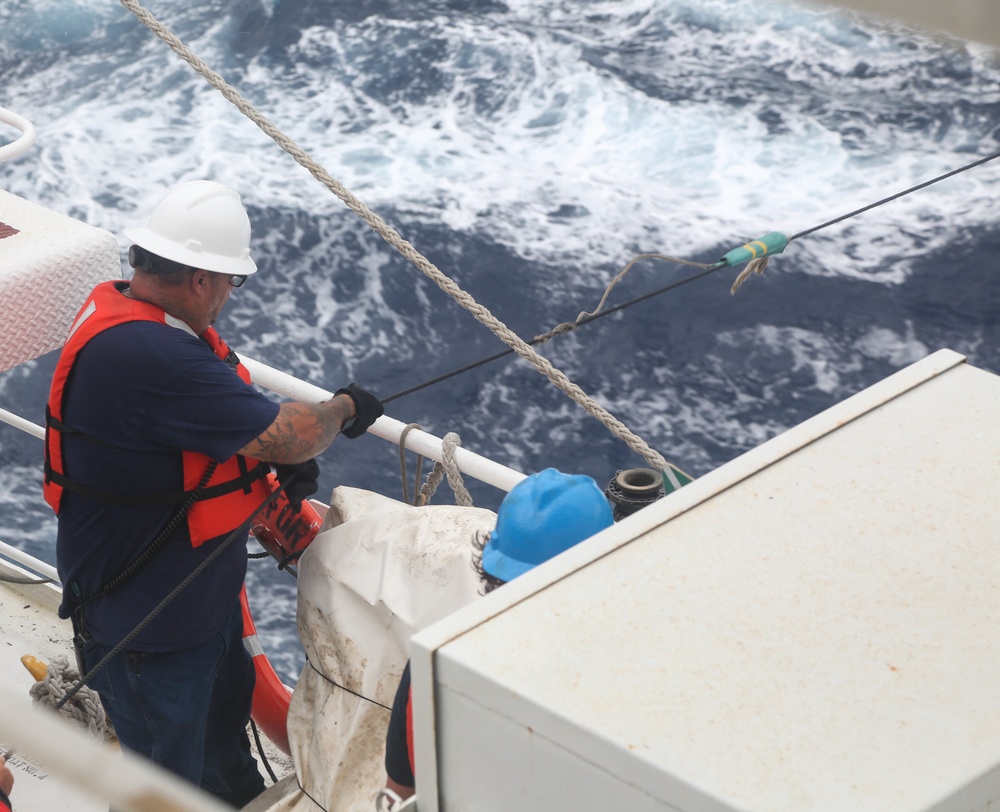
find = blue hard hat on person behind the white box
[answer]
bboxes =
[482,468,614,581]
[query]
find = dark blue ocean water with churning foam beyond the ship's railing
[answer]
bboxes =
[0,0,1000,683]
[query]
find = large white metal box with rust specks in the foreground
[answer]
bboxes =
[414,353,1000,811]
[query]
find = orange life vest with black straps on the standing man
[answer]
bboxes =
[44,282,271,547]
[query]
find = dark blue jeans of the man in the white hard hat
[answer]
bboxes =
[83,602,264,807]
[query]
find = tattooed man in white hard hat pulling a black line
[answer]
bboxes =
[45,181,382,807]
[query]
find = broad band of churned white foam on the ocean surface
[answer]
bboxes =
[4,0,1000,282]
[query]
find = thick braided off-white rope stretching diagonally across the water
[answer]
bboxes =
[120,0,681,490]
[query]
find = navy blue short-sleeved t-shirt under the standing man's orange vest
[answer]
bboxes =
[56,321,279,651]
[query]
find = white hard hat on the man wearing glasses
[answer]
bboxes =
[125,180,257,276]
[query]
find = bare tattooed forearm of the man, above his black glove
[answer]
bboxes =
[240,395,354,465]
